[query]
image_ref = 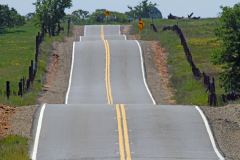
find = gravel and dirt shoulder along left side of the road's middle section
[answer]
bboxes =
[38,26,84,104]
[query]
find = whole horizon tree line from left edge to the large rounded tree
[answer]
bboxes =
[0,0,162,36]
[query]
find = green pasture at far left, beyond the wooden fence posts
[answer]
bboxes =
[0,23,38,105]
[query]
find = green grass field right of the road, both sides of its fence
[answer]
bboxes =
[131,19,223,105]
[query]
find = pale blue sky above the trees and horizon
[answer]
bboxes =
[0,0,239,17]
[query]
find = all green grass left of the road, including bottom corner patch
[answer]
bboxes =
[0,22,67,160]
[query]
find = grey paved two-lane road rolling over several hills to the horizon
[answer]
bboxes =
[32,26,221,160]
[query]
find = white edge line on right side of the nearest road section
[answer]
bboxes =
[195,106,224,160]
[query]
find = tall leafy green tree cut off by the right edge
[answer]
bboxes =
[213,3,240,94]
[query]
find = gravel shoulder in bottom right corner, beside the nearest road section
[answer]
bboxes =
[201,104,240,160]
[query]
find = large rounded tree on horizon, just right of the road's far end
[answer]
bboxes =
[126,0,162,18]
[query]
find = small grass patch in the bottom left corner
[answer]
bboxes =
[0,136,29,160]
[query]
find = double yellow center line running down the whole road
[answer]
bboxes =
[101,26,131,160]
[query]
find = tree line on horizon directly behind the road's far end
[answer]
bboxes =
[68,0,162,24]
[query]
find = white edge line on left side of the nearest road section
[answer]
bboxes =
[32,104,46,160]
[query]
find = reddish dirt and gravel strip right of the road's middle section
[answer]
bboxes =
[141,41,175,104]
